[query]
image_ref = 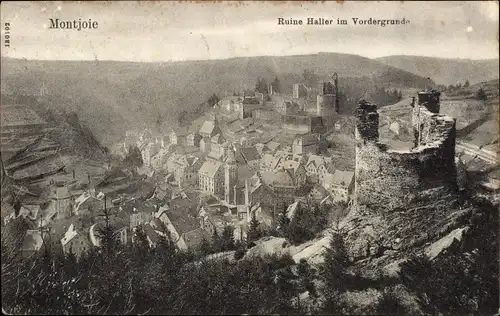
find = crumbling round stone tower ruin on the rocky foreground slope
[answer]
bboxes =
[355,97,456,211]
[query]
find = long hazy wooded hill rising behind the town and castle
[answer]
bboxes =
[1,53,434,145]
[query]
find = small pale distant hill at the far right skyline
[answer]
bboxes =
[375,56,499,85]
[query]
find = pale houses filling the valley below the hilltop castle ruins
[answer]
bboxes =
[2,78,354,256]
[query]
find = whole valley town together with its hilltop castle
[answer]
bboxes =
[2,74,360,257]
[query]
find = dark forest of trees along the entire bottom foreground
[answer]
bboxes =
[1,195,498,315]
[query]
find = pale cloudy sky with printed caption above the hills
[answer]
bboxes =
[1,1,499,62]
